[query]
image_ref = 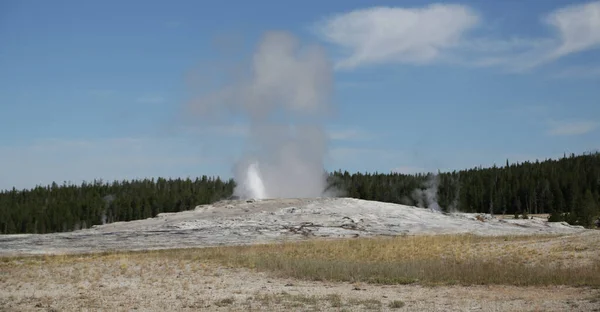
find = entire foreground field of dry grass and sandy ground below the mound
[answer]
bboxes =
[0,231,600,311]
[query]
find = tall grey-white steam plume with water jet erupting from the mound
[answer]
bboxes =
[191,32,333,198]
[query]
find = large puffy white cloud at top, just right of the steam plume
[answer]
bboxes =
[318,4,479,68]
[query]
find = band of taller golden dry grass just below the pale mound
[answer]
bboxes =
[0,235,600,288]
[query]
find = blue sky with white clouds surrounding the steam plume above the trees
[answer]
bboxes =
[0,0,600,189]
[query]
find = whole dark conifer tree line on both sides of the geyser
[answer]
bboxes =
[0,153,600,234]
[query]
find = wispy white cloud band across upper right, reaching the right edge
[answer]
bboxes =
[316,1,600,74]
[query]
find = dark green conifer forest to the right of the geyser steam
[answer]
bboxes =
[329,152,600,226]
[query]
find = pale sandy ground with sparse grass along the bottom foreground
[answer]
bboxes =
[0,257,600,311]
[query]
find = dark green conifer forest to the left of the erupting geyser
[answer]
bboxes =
[0,176,235,234]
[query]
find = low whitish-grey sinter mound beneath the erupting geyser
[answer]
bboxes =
[0,194,586,255]
